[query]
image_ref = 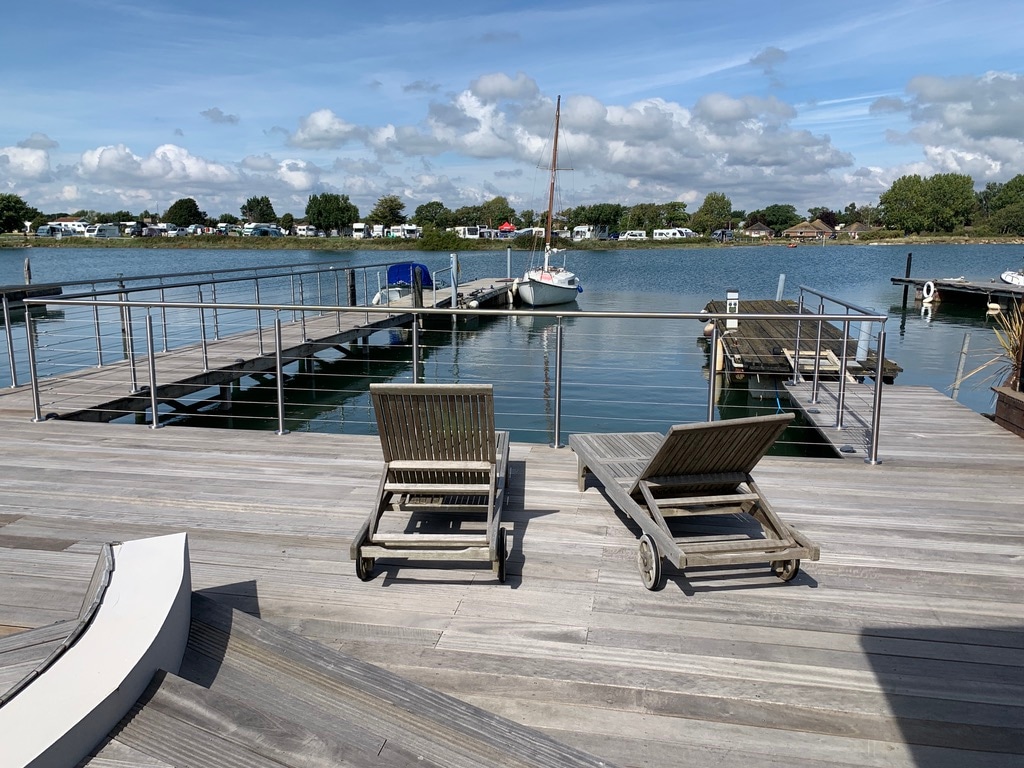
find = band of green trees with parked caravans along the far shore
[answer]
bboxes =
[6,173,1024,236]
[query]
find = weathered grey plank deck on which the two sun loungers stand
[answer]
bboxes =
[0,386,1024,768]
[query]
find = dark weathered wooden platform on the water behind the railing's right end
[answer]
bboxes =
[705,299,903,382]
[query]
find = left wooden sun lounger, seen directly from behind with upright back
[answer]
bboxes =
[349,384,509,582]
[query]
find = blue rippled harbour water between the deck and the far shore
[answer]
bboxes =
[0,245,1022,442]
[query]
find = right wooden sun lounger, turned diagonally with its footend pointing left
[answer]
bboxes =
[569,414,818,590]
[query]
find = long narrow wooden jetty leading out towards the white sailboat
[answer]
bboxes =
[0,279,510,422]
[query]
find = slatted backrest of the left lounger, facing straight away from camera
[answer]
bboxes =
[370,384,496,464]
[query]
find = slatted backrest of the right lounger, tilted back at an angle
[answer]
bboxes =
[637,414,794,493]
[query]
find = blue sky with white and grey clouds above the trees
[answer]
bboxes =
[0,0,1024,218]
